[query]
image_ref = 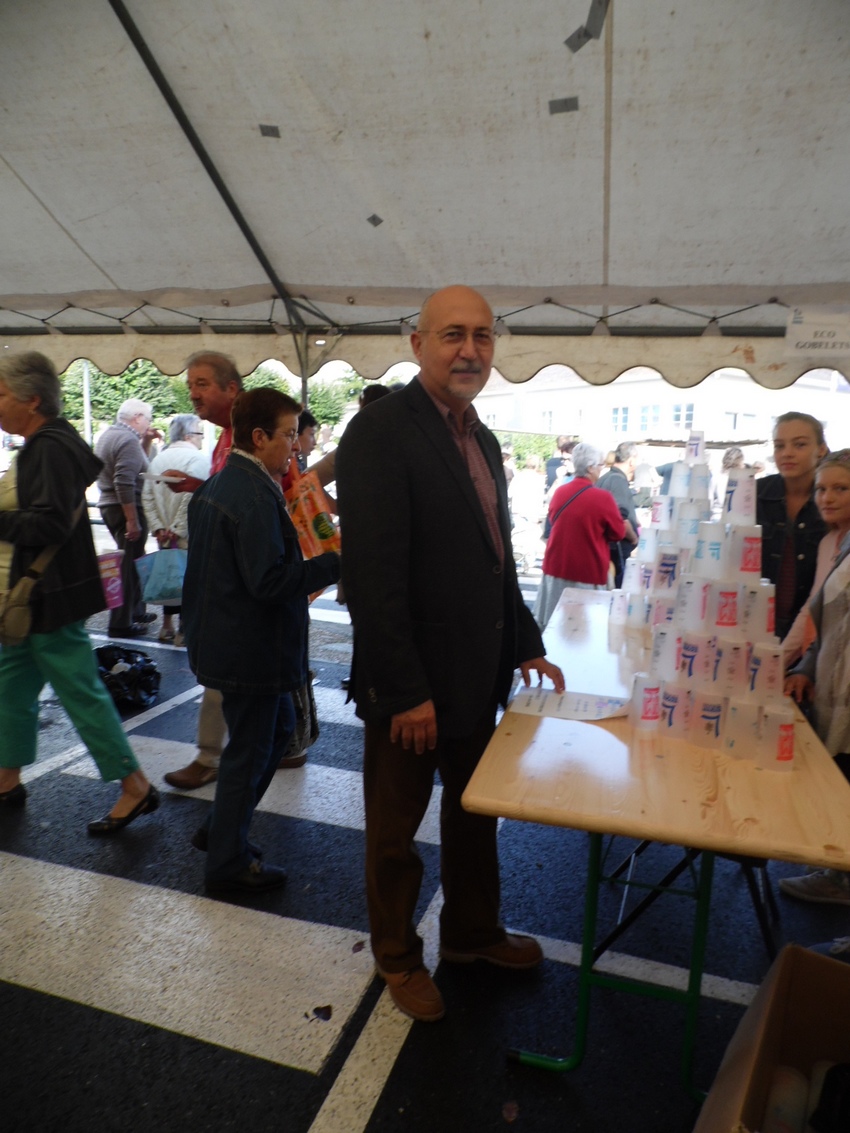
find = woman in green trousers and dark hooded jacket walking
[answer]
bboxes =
[0,351,160,835]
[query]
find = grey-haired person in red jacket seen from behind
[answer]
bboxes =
[534,443,637,629]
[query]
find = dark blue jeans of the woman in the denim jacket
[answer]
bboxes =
[206,692,295,881]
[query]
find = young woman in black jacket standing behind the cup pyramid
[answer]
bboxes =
[756,412,828,639]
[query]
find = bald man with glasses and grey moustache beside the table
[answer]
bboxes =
[337,287,563,1022]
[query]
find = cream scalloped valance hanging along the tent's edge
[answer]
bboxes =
[0,334,850,390]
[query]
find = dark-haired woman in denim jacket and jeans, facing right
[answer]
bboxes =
[182,389,339,892]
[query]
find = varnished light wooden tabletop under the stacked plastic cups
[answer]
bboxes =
[464,590,850,870]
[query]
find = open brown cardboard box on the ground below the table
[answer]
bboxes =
[694,944,850,1133]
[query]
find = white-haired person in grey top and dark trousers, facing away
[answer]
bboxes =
[94,398,156,638]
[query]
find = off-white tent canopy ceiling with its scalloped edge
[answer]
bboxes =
[0,0,850,385]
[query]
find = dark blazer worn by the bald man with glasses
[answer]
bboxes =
[337,378,543,736]
